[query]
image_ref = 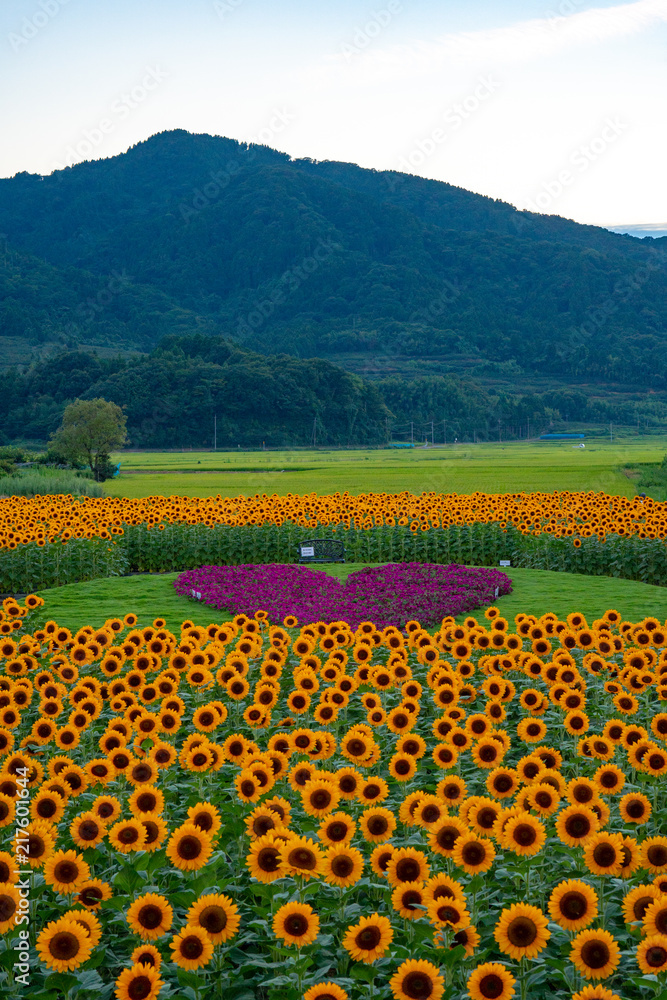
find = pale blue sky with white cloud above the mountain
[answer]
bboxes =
[0,0,667,228]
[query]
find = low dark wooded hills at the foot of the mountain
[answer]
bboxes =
[0,334,667,448]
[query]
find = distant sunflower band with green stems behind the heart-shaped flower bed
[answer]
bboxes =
[0,493,667,593]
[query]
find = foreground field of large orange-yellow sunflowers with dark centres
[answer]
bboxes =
[0,580,667,1000]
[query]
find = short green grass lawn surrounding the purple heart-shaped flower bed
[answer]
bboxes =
[39,563,667,629]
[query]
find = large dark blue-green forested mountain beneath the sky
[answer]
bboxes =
[0,124,667,390]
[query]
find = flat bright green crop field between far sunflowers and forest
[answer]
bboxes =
[105,437,667,497]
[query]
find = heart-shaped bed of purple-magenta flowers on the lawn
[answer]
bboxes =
[174,563,512,628]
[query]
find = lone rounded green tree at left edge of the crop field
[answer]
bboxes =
[51,399,127,483]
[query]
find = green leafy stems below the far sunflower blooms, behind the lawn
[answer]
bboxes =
[0,524,667,594]
